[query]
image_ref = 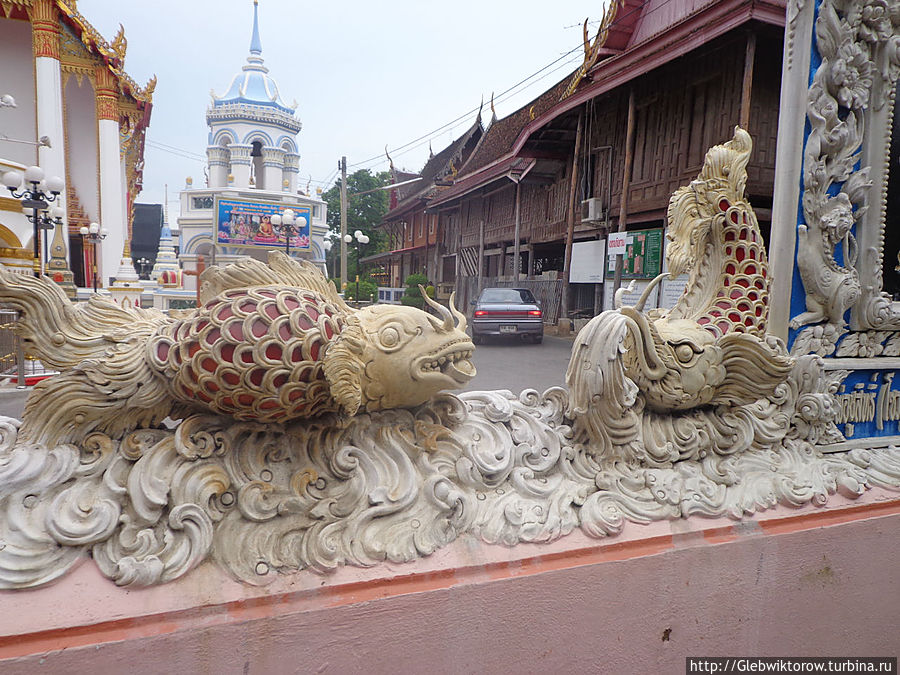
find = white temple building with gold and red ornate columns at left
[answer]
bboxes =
[0,0,156,295]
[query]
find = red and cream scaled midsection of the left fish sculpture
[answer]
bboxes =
[148,287,344,422]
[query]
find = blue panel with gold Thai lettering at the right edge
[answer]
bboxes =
[835,370,900,439]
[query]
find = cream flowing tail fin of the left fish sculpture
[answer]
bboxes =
[0,268,177,443]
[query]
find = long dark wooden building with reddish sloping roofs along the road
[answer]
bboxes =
[381,0,785,320]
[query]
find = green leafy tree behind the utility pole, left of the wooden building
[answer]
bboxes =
[322,169,391,280]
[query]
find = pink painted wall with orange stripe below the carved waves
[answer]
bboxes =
[0,493,900,675]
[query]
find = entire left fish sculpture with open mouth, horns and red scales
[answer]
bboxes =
[0,251,475,442]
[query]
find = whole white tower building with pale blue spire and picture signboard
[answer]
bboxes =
[178,2,327,287]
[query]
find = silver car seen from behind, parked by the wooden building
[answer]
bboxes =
[471,288,544,345]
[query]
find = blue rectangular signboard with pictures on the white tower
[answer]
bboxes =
[214,197,312,250]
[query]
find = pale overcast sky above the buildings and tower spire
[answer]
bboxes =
[78,0,603,211]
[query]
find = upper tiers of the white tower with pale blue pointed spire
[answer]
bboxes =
[206,0,302,194]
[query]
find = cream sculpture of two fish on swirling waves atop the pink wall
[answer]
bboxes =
[0,129,900,588]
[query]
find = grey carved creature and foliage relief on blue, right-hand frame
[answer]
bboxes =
[790,0,900,356]
